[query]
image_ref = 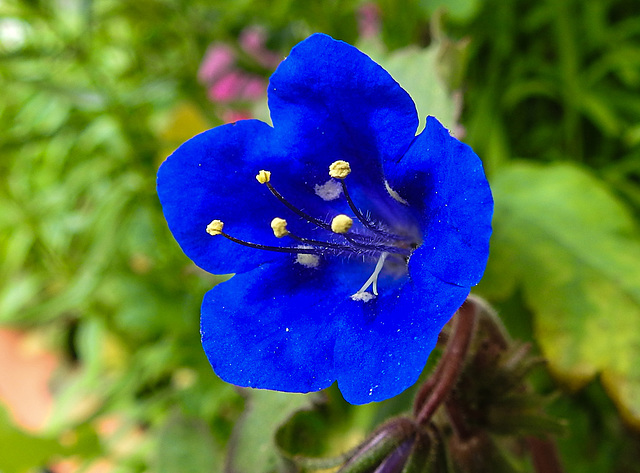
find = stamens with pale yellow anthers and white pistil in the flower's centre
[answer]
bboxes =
[206,161,420,296]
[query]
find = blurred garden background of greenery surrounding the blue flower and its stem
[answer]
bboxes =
[0,0,640,473]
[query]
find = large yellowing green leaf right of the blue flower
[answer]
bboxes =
[479,164,640,425]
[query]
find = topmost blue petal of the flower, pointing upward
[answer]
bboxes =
[268,34,418,198]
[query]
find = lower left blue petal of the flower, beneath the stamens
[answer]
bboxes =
[201,256,368,392]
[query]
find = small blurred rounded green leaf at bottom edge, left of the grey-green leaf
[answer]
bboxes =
[155,411,222,473]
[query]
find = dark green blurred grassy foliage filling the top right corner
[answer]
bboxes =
[459,0,640,179]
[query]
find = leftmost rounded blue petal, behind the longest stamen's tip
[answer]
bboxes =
[157,120,296,274]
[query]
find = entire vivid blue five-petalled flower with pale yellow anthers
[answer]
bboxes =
[158,34,493,404]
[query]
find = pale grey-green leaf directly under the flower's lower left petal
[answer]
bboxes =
[226,390,312,473]
